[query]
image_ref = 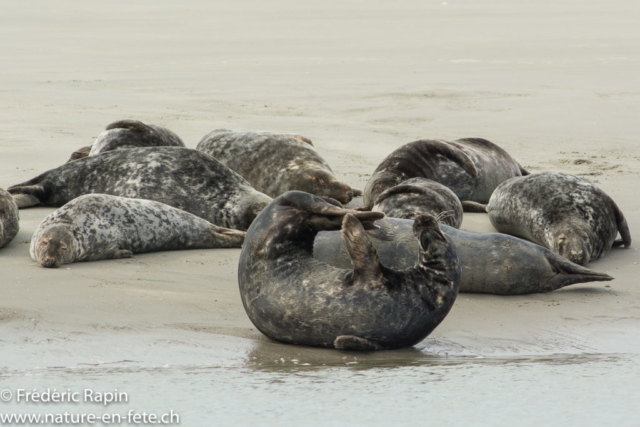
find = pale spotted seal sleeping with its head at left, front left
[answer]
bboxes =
[30,194,246,268]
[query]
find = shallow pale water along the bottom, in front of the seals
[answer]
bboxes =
[0,343,640,426]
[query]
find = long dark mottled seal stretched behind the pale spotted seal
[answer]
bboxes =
[9,147,271,234]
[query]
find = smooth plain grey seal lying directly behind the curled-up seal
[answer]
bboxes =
[313,218,613,295]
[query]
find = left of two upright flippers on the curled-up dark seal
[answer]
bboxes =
[340,214,383,286]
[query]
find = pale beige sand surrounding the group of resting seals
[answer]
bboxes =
[0,0,640,369]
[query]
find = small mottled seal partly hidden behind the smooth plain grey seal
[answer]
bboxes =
[371,178,462,228]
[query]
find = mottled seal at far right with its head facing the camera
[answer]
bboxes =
[487,172,631,265]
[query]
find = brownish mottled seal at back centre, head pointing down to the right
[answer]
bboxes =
[196,129,362,203]
